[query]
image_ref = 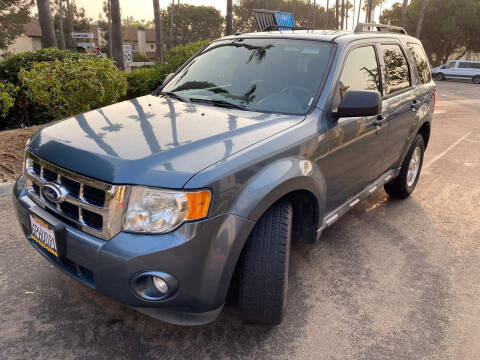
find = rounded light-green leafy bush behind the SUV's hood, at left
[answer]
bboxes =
[19,57,127,119]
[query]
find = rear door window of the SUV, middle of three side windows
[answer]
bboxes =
[382,45,410,95]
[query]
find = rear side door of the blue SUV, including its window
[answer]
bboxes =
[380,43,422,166]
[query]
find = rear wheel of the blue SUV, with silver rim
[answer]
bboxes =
[384,134,425,199]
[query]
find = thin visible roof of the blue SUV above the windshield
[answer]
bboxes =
[223,30,419,43]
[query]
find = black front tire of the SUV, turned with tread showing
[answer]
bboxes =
[237,201,293,325]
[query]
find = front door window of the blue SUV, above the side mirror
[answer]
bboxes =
[338,46,380,98]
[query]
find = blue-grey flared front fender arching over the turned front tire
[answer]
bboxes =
[228,157,326,222]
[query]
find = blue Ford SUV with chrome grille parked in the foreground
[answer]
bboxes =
[14,24,435,325]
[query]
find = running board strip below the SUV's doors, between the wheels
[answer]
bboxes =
[317,169,400,235]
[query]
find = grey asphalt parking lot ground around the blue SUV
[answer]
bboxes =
[0,82,480,359]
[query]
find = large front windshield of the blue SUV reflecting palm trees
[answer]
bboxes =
[162,39,331,114]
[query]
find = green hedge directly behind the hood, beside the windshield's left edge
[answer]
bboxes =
[124,41,209,99]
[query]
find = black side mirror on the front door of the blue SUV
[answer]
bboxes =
[332,91,382,118]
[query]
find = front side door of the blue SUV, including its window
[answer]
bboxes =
[324,45,388,211]
